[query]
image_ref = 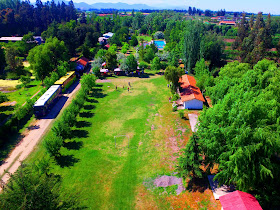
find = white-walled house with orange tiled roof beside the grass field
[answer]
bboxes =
[179,74,205,109]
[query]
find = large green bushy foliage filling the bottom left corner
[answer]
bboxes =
[0,163,82,209]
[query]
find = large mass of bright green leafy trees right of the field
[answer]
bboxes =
[178,60,280,209]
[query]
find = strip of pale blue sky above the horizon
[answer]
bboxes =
[73,0,280,14]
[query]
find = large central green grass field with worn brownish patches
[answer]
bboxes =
[27,76,219,209]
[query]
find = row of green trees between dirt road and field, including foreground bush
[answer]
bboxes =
[0,74,96,209]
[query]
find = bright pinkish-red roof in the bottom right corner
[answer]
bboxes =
[220,190,262,210]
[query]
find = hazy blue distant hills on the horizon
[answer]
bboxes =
[74,2,155,10]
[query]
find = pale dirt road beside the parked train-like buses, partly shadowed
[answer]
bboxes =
[0,81,81,185]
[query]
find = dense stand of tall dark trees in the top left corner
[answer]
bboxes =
[0,0,77,37]
